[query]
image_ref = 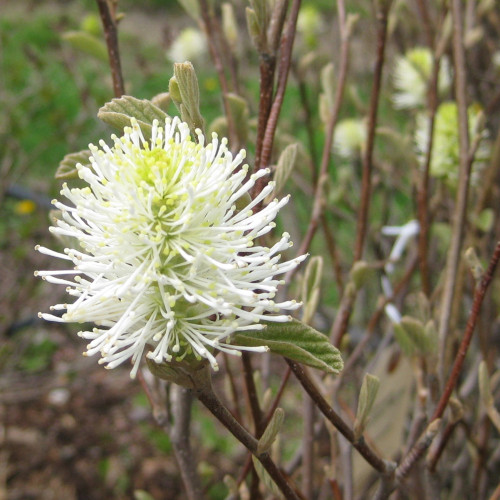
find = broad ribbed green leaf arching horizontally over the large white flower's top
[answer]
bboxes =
[97,95,167,139]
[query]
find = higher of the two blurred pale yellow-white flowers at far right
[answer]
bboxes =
[393,47,451,109]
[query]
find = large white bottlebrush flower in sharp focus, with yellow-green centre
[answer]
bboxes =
[36,118,305,376]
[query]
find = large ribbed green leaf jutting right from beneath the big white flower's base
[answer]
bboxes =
[233,319,344,373]
